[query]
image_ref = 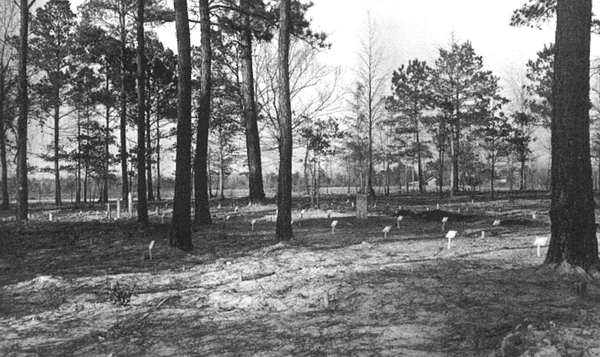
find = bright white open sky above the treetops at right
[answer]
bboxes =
[310,0,554,82]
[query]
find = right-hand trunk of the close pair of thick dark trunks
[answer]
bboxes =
[194,0,212,225]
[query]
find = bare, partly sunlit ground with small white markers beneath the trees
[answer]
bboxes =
[0,193,600,357]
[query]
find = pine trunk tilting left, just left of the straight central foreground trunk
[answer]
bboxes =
[240,0,265,203]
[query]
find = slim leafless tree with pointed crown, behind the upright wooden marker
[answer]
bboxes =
[355,13,388,197]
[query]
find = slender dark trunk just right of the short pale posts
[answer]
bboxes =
[137,0,148,224]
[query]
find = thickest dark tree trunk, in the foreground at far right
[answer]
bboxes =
[544,0,600,275]
